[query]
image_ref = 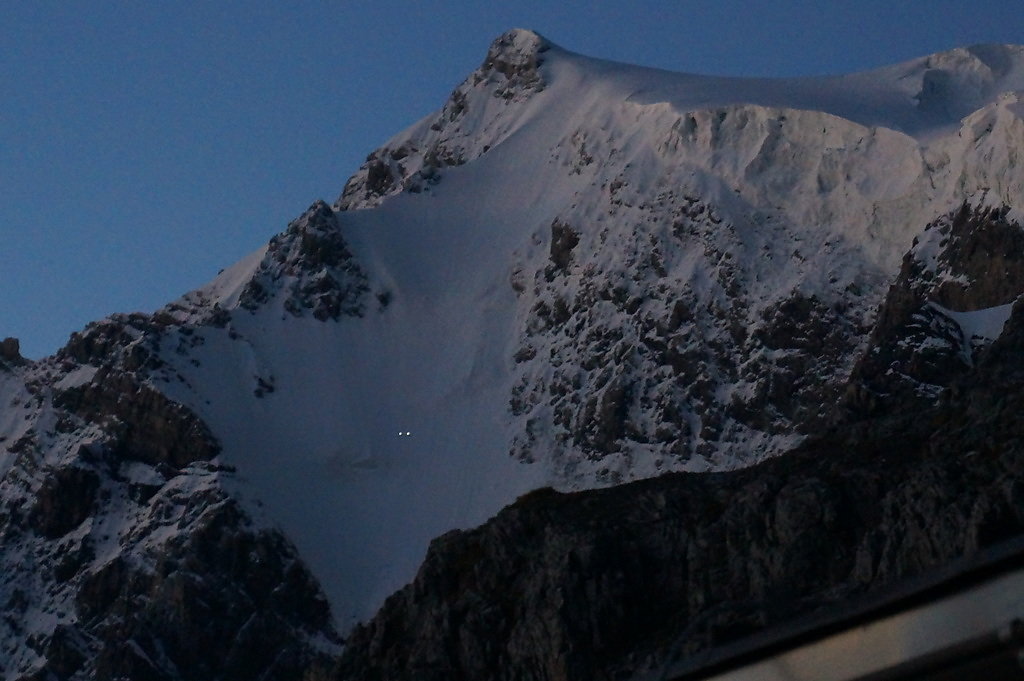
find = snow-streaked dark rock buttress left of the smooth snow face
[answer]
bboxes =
[0,305,340,681]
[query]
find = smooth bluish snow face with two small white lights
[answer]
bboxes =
[153,182,561,625]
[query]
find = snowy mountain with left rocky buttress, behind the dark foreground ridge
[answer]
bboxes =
[0,31,1024,678]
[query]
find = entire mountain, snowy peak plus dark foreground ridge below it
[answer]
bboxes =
[0,31,1024,681]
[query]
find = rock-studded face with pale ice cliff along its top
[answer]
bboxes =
[495,84,1024,481]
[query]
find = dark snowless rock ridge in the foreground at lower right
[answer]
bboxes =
[335,299,1024,681]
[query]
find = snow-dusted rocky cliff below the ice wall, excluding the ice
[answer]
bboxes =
[510,188,883,483]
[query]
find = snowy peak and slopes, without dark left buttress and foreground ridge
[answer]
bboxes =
[6,31,1024,647]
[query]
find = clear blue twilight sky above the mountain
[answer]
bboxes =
[6,0,1024,357]
